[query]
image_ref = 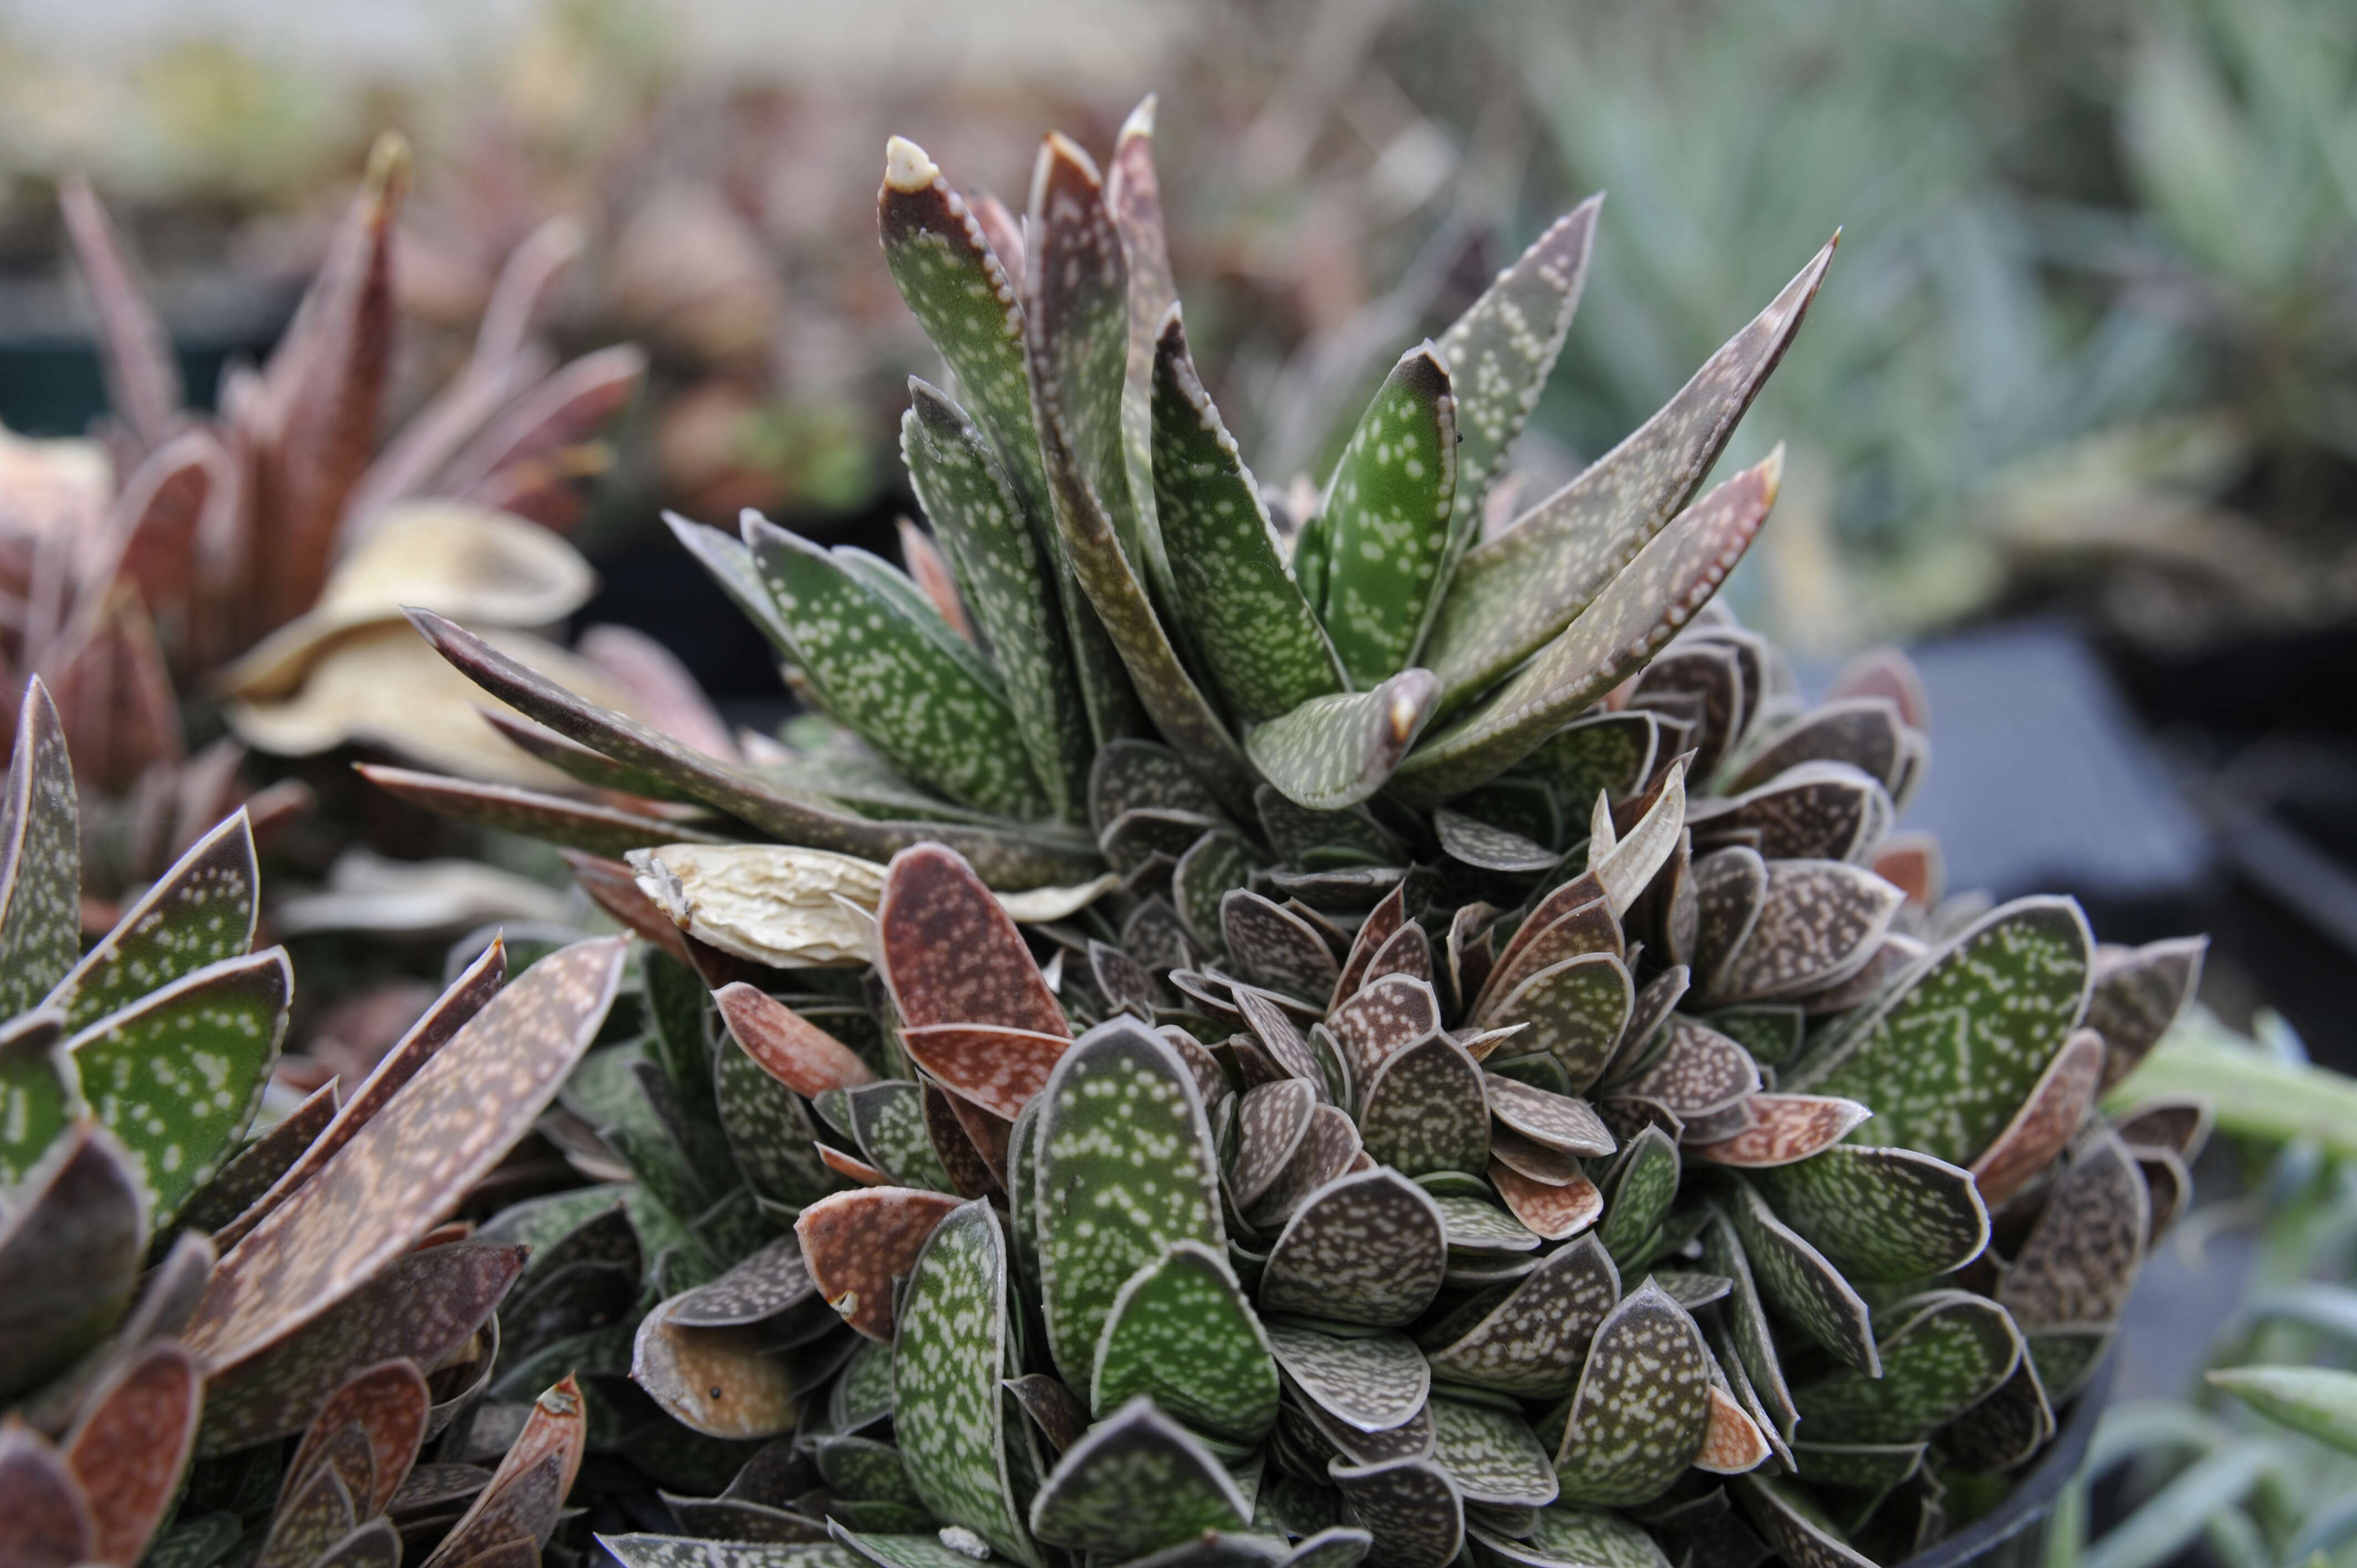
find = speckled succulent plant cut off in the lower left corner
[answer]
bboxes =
[0,679,622,1568]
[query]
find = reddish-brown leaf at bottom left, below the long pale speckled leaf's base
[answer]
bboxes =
[59,1339,203,1563]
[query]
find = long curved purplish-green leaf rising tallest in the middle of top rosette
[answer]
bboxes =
[1023,137,1252,811]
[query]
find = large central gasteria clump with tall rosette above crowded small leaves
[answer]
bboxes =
[375,101,2201,1568]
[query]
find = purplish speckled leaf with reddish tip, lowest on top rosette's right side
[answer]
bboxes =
[1393,448,1784,806]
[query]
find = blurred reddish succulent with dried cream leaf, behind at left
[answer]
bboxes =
[0,142,641,891]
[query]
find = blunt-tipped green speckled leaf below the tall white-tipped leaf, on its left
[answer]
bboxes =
[900,377,1089,821]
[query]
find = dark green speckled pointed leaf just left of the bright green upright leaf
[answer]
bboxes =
[1155,309,1346,724]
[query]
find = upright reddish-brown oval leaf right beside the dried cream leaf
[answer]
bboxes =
[877,844,1070,1035]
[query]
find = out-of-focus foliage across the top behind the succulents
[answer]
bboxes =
[0,0,2357,663]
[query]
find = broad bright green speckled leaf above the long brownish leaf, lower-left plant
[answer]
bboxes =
[66,948,295,1229]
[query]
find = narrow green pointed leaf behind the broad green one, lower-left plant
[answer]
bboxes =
[47,806,259,1030]
